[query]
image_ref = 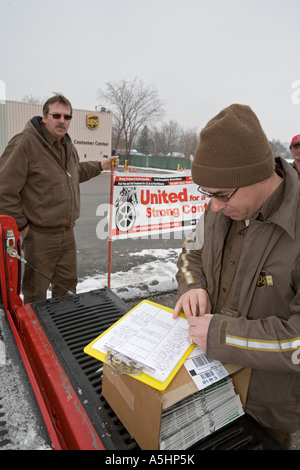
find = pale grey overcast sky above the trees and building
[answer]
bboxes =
[0,0,300,142]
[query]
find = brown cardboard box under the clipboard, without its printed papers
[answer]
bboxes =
[102,364,251,450]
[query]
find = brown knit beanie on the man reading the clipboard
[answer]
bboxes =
[192,104,275,189]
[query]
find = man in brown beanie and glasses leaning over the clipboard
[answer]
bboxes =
[174,104,300,448]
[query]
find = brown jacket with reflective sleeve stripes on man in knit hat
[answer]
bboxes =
[177,158,300,432]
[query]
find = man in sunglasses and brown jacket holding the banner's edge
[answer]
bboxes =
[0,95,118,303]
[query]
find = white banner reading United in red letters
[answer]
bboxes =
[111,173,208,240]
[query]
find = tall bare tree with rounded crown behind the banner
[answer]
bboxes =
[98,78,164,159]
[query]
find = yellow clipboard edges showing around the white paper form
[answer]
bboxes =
[84,300,195,390]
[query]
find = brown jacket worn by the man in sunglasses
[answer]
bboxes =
[0,116,101,230]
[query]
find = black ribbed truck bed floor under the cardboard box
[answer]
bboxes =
[31,288,281,451]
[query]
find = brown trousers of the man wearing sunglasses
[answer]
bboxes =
[22,227,78,304]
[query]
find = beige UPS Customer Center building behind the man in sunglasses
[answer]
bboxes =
[0,101,112,161]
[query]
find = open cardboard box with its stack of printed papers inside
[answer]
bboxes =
[102,364,251,450]
